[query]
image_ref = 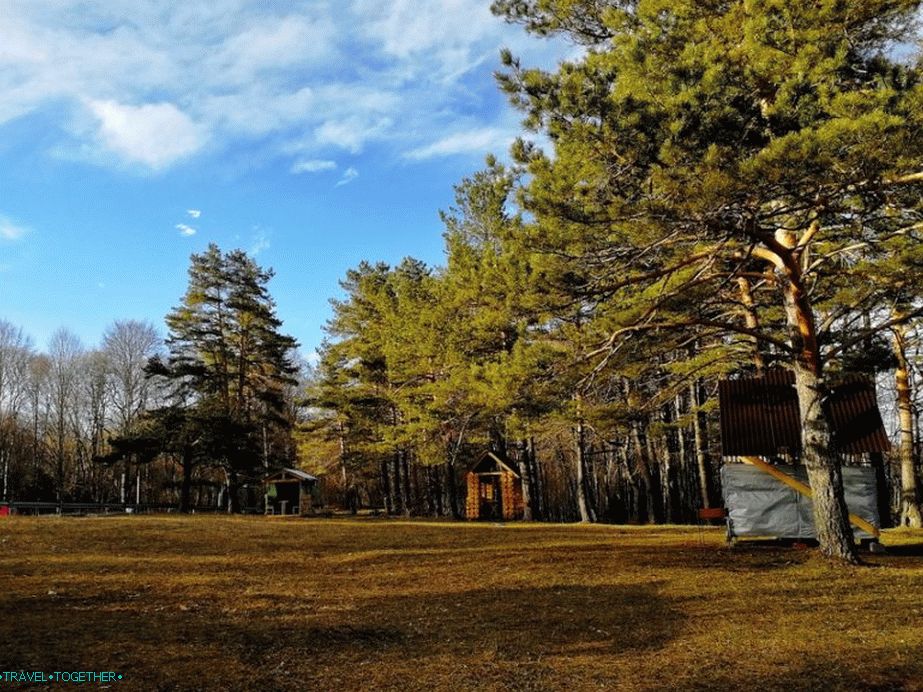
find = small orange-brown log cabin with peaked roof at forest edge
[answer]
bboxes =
[465,452,524,521]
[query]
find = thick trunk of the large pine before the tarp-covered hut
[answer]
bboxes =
[782,266,859,563]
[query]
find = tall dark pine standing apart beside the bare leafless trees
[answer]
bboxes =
[159,244,297,511]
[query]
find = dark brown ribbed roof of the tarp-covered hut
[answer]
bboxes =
[718,369,891,457]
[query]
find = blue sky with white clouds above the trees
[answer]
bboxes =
[0,0,576,357]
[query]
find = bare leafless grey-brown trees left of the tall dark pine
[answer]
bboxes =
[0,320,160,502]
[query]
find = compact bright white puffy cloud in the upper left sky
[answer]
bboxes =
[89,101,206,169]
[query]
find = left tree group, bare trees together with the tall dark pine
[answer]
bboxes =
[0,245,302,511]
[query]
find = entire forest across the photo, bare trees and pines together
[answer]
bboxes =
[0,0,923,560]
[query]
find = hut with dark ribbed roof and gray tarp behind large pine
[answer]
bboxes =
[718,370,890,539]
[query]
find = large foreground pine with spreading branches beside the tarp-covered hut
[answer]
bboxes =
[494,0,923,562]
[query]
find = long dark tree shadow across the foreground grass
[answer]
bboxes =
[0,585,682,689]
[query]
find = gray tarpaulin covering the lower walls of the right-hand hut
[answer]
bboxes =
[721,464,881,539]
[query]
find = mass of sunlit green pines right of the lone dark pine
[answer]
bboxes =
[304,0,923,561]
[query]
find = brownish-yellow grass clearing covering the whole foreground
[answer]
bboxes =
[0,516,923,692]
